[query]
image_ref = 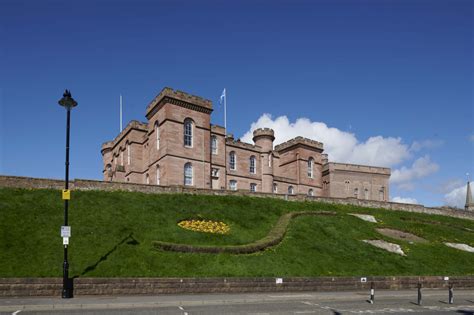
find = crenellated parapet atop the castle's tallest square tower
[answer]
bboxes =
[146,87,212,118]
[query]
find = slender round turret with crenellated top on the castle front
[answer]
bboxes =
[253,128,275,193]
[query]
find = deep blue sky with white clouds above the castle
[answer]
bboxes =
[0,0,474,207]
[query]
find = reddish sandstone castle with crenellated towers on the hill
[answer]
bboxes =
[101,88,390,201]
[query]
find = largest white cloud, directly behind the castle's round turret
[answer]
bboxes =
[242,114,410,167]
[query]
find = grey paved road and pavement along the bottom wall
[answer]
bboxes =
[0,289,474,315]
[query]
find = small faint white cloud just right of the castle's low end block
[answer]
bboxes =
[390,155,439,188]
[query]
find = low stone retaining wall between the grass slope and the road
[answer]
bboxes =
[0,276,474,297]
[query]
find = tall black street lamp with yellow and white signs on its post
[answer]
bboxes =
[58,90,77,299]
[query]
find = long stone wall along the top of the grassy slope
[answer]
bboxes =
[0,176,474,220]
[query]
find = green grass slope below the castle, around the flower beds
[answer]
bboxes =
[0,189,474,277]
